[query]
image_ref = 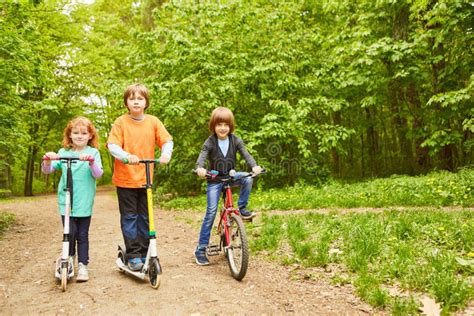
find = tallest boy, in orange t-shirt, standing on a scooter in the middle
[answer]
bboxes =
[107,84,173,271]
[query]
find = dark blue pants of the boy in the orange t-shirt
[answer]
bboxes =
[117,187,150,260]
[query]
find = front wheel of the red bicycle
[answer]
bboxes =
[227,214,249,281]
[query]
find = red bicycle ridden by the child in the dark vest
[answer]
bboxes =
[194,170,265,281]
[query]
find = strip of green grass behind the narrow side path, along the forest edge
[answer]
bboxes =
[158,169,474,211]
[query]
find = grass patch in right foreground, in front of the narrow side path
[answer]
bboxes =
[248,210,474,314]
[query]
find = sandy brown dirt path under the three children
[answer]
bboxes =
[0,190,374,315]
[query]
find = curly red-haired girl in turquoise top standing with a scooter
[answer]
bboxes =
[41,117,103,282]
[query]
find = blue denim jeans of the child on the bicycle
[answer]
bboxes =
[198,172,253,249]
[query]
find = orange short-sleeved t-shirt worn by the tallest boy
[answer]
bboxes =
[107,114,173,188]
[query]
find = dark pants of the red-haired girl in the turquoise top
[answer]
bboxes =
[61,216,91,265]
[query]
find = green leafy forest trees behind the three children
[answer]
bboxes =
[0,0,474,195]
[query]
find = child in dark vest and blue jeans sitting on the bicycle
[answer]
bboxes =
[194,107,262,265]
